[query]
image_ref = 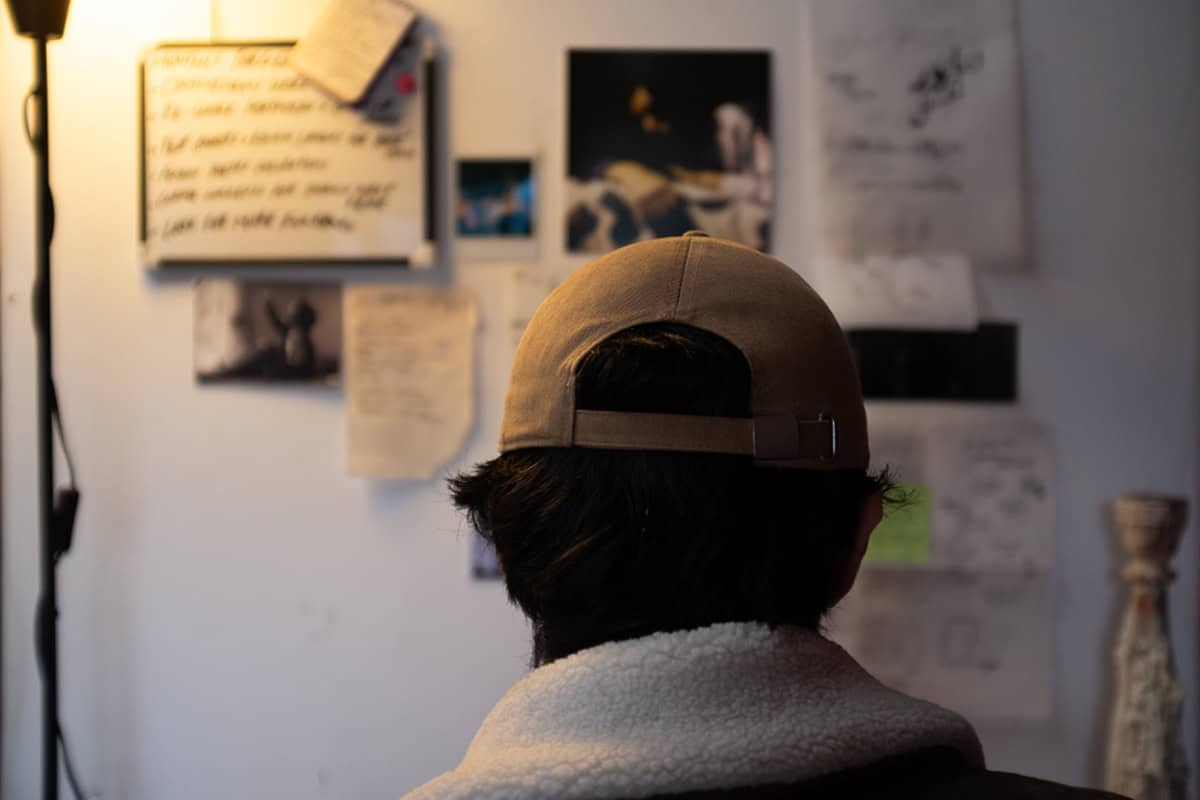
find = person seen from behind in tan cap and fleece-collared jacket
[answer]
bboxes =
[410,234,1111,800]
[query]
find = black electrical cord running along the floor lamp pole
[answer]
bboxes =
[20,84,88,800]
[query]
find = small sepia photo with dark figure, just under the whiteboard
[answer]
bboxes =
[193,279,342,384]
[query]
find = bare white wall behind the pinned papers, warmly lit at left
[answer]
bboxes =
[0,0,1200,800]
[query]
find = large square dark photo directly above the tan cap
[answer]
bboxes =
[565,49,775,253]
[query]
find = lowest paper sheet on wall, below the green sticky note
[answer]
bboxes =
[832,566,1054,720]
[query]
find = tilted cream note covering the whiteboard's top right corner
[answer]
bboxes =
[292,0,416,103]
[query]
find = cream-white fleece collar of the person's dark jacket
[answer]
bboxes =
[407,622,983,800]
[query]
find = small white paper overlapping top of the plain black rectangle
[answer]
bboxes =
[820,253,979,330]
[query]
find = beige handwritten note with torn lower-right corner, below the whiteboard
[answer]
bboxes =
[344,285,476,479]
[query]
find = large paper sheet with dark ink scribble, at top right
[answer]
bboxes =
[810,0,1027,270]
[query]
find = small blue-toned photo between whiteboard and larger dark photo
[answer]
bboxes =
[455,158,535,239]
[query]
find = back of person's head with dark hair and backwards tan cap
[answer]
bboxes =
[451,237,887,664]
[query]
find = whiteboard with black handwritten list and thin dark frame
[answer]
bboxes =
[140,41,433,266]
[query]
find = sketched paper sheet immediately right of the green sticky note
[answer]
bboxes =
[929,425,1055,572]
